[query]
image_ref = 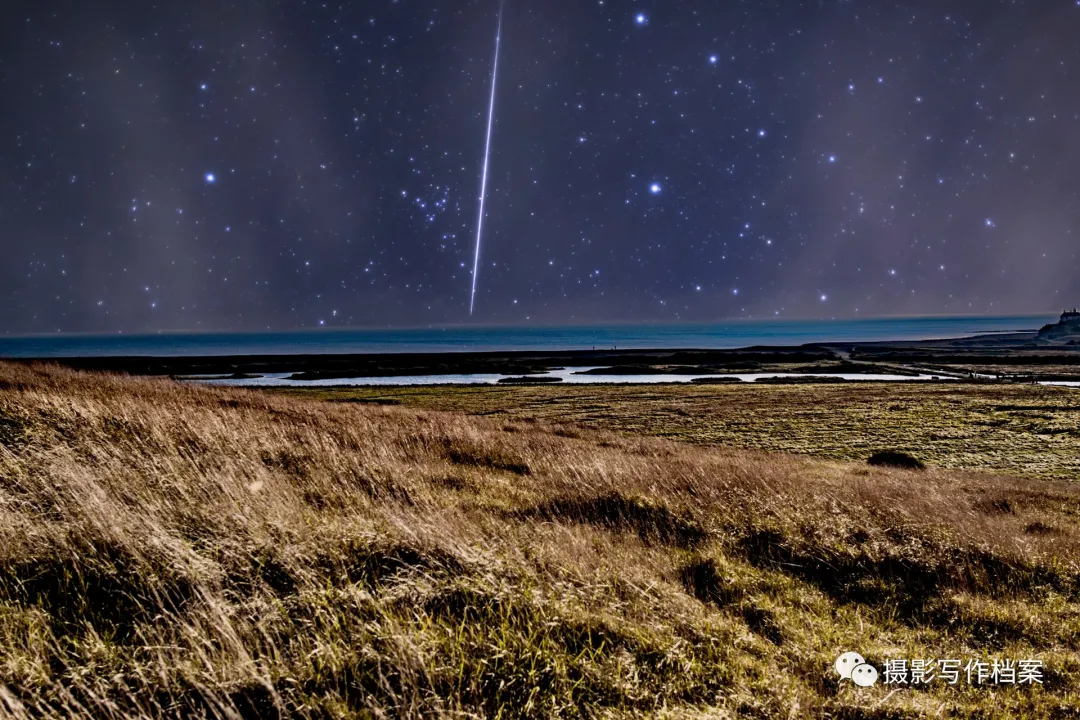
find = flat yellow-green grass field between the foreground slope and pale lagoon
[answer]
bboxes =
[272,382,1080,479]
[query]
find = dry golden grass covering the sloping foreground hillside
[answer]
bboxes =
[0,364,1080,719]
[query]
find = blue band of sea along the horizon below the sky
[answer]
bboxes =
[0,314,1057,357]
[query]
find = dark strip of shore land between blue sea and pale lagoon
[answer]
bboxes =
[2,330,1080,381]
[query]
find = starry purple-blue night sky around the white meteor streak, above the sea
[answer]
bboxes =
[0,0,1080,334]
